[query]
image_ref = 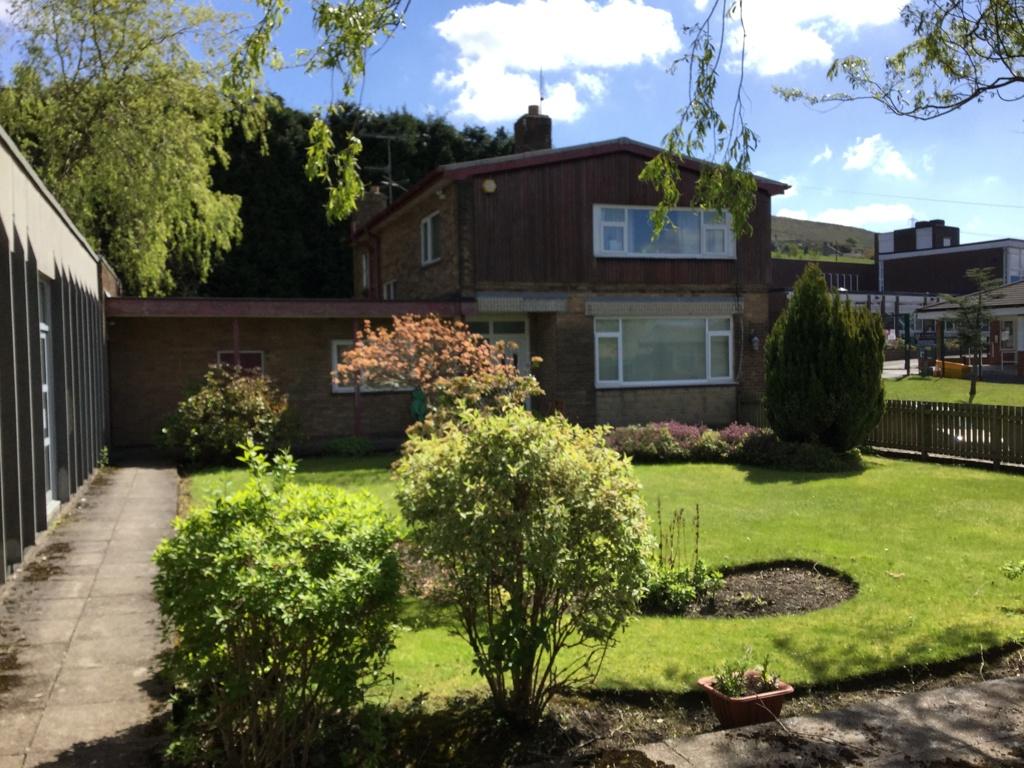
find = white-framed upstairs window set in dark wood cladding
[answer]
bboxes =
[594,205,736,259]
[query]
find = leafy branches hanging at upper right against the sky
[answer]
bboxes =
[643,0,1024,234]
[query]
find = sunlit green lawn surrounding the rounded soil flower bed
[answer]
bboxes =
[186,457,1024,700]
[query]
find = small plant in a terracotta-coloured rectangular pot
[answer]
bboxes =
[697,652,793,728]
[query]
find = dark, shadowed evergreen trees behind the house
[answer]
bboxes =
[201,103,512,298]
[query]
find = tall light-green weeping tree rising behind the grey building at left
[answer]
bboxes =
[0,0,241,295]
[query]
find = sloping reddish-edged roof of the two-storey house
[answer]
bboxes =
[361,136,790,229]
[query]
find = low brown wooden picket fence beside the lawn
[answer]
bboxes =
[740,400,1024,465]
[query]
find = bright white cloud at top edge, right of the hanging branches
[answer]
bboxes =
[716,0,905,76]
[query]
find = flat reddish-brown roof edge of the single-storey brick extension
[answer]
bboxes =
[106,297,475,319]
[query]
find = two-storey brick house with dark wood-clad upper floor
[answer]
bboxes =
[353,106,786,424]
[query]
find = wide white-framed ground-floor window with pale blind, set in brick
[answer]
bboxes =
[594,317,733,388]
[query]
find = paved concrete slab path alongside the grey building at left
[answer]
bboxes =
[0,468,177,768]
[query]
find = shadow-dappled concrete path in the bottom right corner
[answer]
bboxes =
[641,678,1024,768]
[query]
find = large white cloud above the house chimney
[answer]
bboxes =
[432,0,682,123]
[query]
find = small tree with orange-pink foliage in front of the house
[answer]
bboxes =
[334,314,542,409]
